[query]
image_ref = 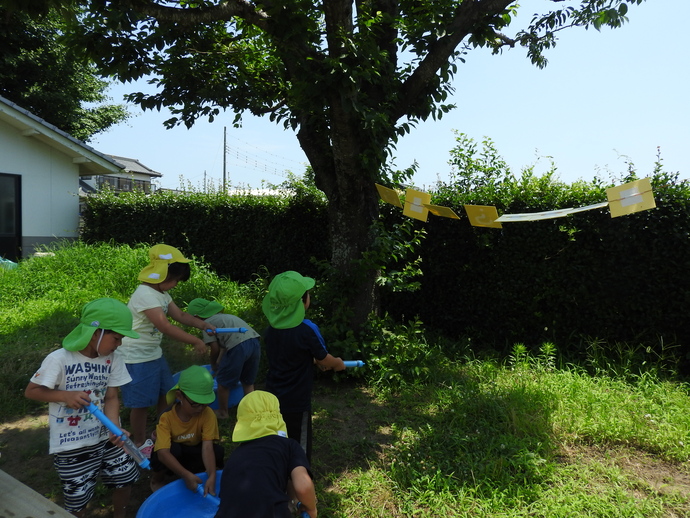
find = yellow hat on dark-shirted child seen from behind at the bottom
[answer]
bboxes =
[232,390,287,442]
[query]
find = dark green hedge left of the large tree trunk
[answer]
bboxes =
[82,190,330,282]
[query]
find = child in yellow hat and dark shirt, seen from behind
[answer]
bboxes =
[215,390,317,518]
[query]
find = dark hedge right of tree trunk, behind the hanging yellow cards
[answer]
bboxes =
[386,171,690,366]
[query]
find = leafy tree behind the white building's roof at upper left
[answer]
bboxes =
[0,9,129,141]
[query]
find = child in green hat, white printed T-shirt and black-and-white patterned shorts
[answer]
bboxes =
[24,298,139,518]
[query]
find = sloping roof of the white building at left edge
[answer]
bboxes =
[0,96,124,176]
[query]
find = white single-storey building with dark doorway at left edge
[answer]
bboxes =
[0,96,133,261]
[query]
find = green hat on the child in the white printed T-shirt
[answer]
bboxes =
[62,298,139,351]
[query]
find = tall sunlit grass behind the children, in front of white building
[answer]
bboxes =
[0,242,264,418]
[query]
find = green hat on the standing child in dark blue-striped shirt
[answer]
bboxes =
[261,271,316,329]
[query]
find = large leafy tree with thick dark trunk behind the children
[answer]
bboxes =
[2,0,643,324]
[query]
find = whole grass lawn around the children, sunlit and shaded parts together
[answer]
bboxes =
[0,247,690,518]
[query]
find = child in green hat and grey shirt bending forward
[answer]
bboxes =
[187,298,261,419]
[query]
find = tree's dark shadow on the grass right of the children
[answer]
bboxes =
[313,367,556,516]
